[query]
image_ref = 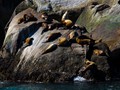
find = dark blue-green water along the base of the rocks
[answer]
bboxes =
[0,81,120,90]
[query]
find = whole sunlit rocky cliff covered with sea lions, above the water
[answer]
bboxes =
[0,0,120,82]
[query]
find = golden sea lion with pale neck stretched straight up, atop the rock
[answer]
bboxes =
[61,11,73,28]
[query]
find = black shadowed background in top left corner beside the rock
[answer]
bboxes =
[0,0,22,47]
